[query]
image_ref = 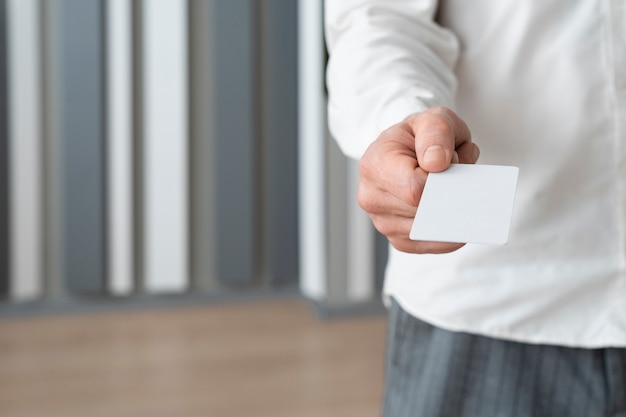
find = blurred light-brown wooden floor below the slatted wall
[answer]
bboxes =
[0,300,385,417]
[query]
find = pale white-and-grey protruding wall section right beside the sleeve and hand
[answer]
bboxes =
[298,0,387,314]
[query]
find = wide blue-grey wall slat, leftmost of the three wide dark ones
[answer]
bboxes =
[61,0,105,293]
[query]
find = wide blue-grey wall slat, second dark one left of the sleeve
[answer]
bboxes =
[214,0,259,284]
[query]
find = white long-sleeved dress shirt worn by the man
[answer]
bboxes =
[325,0,626,347]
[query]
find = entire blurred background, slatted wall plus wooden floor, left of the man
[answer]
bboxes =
[0,0,386,417]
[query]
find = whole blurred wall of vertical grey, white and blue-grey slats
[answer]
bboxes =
[0,0,385,312]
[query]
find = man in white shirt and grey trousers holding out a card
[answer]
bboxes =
[325,0,626,417]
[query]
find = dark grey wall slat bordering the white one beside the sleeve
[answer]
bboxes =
[261,0,298,284]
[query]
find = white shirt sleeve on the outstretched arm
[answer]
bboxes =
[325,0,459,159]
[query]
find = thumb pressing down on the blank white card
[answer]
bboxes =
[407,107,471,172]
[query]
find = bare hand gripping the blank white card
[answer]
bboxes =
[357,107,480,253]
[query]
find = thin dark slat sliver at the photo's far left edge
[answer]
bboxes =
[0,0,9,299]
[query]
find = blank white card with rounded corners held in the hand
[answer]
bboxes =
[409,164,519,245]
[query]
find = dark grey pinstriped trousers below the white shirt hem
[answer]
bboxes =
[383,301,626,417]
